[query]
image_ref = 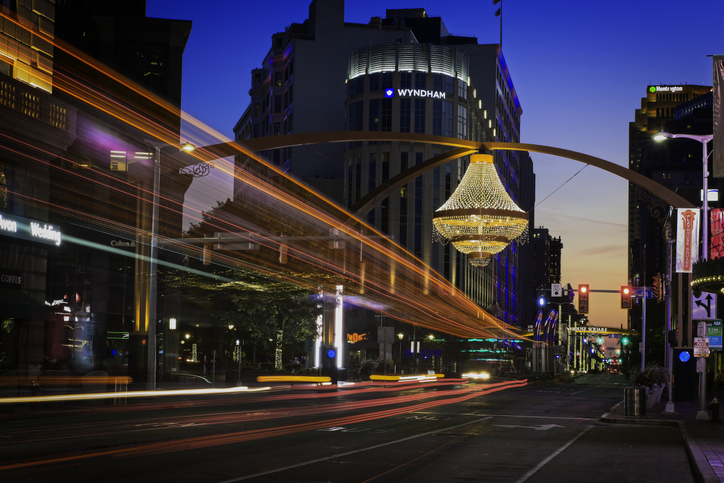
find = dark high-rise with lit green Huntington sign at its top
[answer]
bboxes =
[622,85,719,360]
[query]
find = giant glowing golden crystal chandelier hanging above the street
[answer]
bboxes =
[432,154,528,267]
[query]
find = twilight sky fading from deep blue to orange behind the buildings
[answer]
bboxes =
[147,0,724,327]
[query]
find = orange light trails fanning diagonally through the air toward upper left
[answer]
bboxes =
[3,15,532,338]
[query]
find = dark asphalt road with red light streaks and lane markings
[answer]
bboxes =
[0,375,694,483]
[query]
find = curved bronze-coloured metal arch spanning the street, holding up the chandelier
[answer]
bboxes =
[207,131,696,216]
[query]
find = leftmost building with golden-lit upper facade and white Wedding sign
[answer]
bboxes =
[0,0,77,370]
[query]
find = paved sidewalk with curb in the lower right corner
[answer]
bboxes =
[600,394,724,483]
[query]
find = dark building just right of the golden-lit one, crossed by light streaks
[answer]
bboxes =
[48,0,192,382]
